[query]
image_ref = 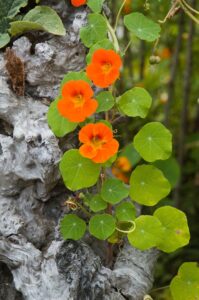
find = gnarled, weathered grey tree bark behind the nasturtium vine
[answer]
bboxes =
[0,1,157,300]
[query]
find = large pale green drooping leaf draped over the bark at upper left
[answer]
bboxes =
[9,6,66,36]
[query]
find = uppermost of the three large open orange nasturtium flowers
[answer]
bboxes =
[86,49,122,88]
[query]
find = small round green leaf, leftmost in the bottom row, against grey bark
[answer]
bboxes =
[60,214,86,241]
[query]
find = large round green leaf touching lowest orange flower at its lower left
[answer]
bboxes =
[59,150,100,191]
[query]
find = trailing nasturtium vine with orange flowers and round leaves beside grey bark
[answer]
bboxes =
[44,0,191,292]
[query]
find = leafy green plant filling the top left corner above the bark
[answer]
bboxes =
[0,0,66,48]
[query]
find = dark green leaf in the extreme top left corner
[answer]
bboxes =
[0,0,28,20]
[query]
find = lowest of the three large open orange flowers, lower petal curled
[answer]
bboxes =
[79,123,119,163]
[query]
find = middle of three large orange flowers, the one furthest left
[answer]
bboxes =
[57,80,98,122]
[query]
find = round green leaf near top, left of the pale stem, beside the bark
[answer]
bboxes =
[80,14,107,48]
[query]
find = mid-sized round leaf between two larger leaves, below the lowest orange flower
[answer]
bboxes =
[101,178,129,204]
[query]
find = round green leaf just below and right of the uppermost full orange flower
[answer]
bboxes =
[118,87,152,118]
